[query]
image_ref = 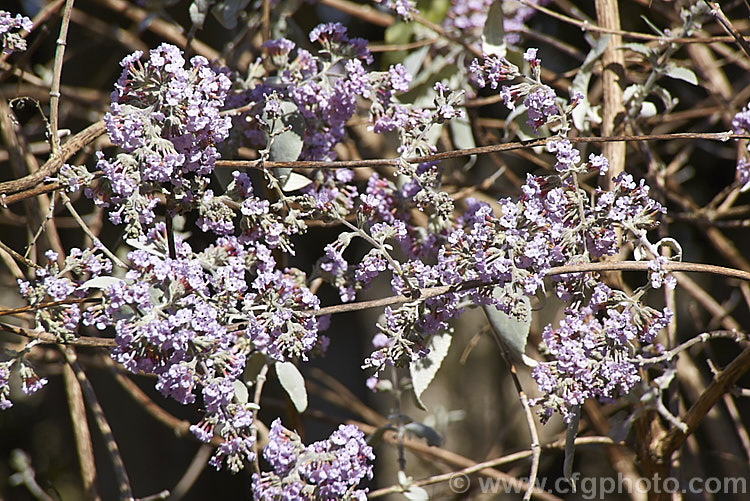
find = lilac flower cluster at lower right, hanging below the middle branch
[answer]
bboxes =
[532,283,672,421]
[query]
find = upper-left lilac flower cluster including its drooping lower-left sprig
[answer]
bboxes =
[87,44,231,230]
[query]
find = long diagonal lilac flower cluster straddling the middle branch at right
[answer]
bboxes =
[363,140,664,371]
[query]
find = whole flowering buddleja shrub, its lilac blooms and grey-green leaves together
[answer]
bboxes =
[0,1,750,499]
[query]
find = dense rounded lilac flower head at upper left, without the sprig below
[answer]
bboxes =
[105,44,231,185]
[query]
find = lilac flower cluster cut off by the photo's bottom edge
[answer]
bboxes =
[253,419,375,501]
